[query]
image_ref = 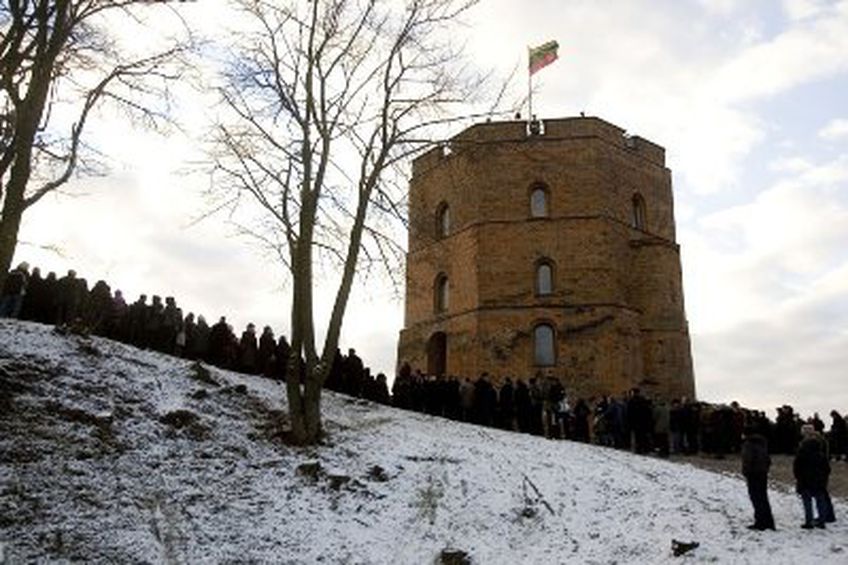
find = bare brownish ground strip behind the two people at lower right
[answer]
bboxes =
[670,454,848,500]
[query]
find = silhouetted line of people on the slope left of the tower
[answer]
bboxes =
[0,263,390,404]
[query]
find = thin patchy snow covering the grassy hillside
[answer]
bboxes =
[0,321,848,564]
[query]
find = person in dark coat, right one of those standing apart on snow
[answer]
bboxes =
[792,424,830,529]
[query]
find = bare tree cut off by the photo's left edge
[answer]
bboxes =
[0,0,187,285]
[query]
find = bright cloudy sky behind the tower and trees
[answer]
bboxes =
[17,0,848,415]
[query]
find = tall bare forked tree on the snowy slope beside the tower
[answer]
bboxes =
[209,0,494,444]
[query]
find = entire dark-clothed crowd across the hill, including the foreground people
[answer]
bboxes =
[0,263,848,530]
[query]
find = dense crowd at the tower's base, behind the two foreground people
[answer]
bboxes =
[392,365,848,460]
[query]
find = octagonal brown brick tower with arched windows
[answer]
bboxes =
[398,117,695,398]
